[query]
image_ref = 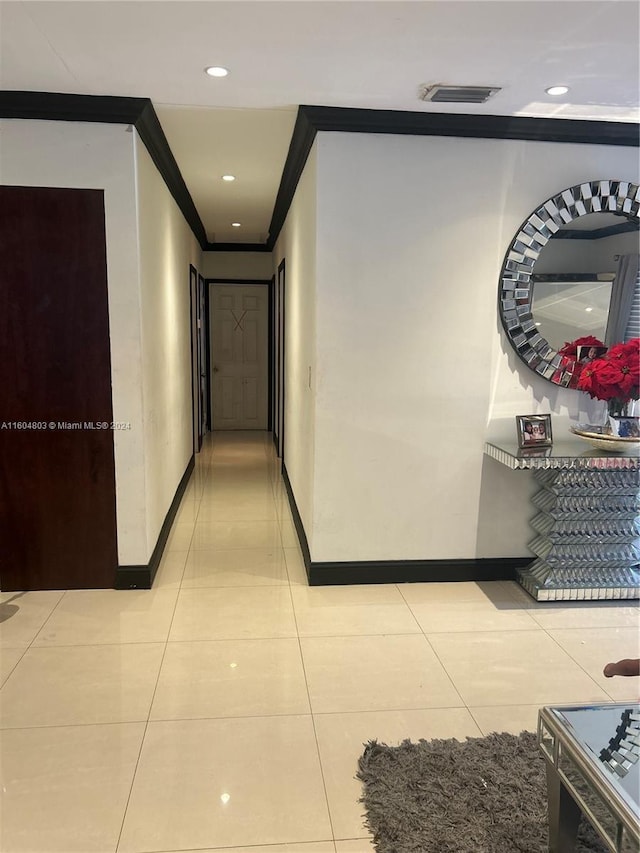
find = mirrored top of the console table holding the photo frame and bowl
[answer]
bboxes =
[484,436,640,471]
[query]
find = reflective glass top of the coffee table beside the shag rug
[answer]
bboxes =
[541,702,640,814]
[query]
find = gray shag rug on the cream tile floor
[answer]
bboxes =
[357,732,606,853]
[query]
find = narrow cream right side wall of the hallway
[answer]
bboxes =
[273,145,319,536]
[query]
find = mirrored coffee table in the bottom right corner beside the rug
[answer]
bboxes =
[538,703,640,853]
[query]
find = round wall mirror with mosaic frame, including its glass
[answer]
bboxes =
[499,181,640,387]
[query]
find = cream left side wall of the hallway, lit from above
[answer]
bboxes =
[135,134,201,562]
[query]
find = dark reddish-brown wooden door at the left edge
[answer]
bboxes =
[0,187,117,591]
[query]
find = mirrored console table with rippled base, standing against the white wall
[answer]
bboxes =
[485,438,640,601]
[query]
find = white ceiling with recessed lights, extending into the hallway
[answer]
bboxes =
[0,0,640,243]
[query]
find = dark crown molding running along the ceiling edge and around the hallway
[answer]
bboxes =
[0,91,640,252]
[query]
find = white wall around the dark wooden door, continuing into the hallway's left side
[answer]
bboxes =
[0,119,200,565]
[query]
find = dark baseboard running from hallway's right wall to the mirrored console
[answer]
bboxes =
[282,466,533,586]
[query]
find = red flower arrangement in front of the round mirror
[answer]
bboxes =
[559,335,640,413]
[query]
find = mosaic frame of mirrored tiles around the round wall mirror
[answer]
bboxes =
[498,180,640,387]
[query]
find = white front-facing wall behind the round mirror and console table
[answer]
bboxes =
[308,133,638,561]
